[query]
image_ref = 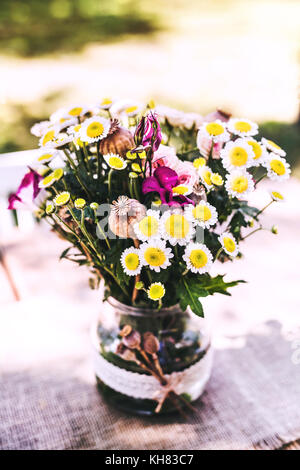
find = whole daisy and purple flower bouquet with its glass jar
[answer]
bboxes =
[9,99,290,414]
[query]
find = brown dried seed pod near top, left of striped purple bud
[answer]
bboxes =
[99,119,135,157]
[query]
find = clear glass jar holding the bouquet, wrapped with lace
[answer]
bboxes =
[92,297,212,415]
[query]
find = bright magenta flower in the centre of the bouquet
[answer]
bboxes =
[142,166,194,206]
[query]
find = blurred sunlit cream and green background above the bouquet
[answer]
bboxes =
[0,0,300,175]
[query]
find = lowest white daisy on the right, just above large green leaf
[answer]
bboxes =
[183,243,213,274]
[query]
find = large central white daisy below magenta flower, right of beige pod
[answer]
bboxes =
[160,209,195,246]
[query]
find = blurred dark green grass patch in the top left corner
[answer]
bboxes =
[0,0,160,57]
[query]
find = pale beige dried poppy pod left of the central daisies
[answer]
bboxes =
[108,196,146,238]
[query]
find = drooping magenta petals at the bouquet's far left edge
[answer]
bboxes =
[8,168,43,209]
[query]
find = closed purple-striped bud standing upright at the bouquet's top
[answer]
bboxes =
[134,112,162,152]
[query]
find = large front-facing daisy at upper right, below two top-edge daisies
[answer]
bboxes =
[220,139,255,171]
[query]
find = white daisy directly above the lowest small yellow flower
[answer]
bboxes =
[140,240,174,273]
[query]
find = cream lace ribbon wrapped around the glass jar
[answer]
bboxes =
[93,347,213,400]
